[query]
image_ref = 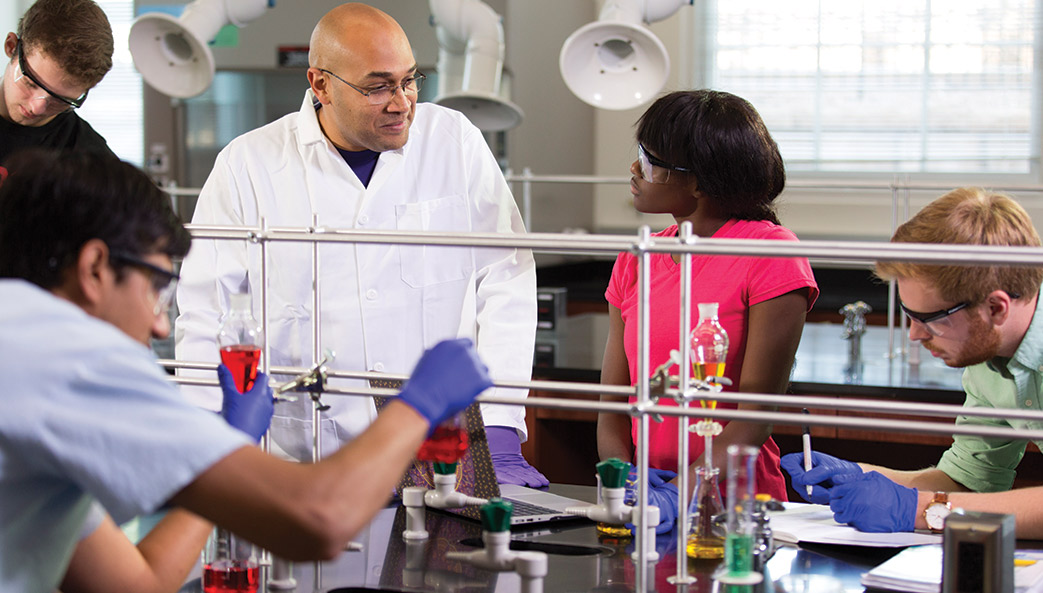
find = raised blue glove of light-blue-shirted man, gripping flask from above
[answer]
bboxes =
[398,338,492,435]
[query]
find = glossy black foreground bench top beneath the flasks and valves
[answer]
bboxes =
[180,485,947,593]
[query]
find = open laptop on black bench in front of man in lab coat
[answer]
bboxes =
[369,380,590,526]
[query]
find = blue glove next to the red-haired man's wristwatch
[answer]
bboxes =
[829,471,919,534]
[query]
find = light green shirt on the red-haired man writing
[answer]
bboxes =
[938,289,1043,492]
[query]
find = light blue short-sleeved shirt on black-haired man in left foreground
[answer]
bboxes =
[0,279,251,592]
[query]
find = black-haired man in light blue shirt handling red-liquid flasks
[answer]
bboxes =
[0,152,491,593]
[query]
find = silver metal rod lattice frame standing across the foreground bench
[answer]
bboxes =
[160,221,1043,591]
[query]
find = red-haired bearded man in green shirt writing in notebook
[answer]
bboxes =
[781,188,1043,538]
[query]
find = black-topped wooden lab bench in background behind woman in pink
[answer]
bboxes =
[523,313,1043,493]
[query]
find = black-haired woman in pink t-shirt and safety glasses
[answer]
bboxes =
[598,90,819,532]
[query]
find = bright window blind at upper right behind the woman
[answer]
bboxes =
[697,0,1041,174]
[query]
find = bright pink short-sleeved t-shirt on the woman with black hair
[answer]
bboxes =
[605,220,819,500]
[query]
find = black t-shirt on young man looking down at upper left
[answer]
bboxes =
[0,112,115,176]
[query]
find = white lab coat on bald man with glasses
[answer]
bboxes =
[175,91,536,459]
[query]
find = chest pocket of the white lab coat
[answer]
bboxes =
[395,196,472,288]
